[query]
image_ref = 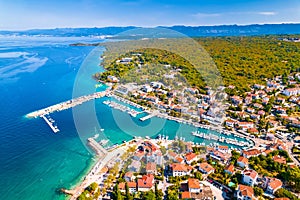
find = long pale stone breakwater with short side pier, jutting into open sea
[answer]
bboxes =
[26,90,110,133]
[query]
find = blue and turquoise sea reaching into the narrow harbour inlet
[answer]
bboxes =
[0,36,248,200]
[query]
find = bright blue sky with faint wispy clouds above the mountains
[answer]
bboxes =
[0,0,300,30]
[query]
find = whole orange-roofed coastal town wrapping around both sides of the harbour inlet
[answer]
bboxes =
[78,54,300,199]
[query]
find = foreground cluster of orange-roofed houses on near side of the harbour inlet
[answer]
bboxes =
[78,138,300,199]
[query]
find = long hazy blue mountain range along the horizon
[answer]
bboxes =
[0,24,300,37]
